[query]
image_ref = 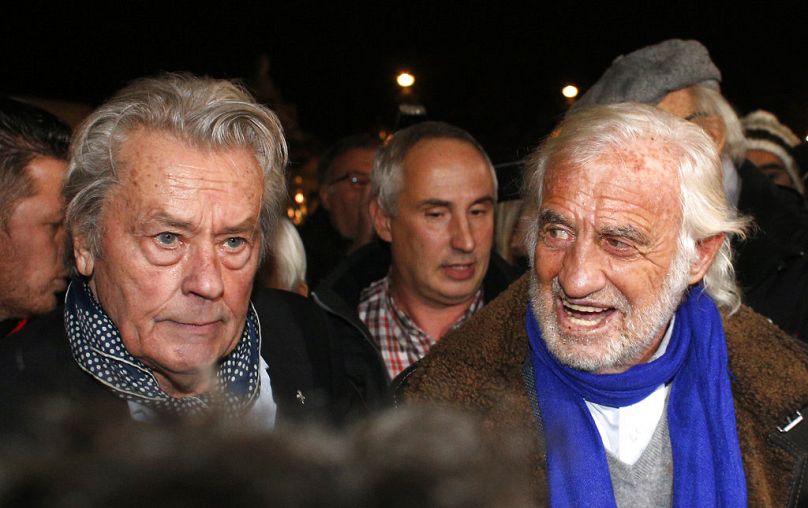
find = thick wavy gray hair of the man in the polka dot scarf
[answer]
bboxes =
[64,74,287,266]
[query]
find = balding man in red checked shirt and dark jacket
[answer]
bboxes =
[315,121,514,378]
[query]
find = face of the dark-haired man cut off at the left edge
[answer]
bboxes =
[0,157,67,319]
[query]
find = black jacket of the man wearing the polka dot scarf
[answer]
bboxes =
[0,289,387,429]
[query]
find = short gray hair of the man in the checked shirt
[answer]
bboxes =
[370,121,497,216]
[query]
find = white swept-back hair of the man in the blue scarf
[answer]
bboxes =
[526,103,750,313]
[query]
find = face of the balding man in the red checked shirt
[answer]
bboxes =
[374,139,496,308]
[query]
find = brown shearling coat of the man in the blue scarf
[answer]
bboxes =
[408,274,808,506]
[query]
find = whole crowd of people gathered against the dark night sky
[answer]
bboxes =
[0,39,808,507]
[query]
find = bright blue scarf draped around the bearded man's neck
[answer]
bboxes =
[527,286,746,507]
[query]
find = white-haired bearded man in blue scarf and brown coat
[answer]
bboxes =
[401,104,808,507]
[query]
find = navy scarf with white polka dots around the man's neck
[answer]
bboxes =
[65,278,261,417]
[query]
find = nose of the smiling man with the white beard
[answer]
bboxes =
[558,239,606,298]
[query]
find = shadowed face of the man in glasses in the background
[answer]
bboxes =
[320,148,376,239]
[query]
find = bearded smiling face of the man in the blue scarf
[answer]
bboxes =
[532,142,689,373]
